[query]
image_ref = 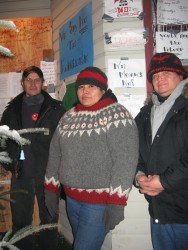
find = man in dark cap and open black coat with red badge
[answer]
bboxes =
[0,66,64,250]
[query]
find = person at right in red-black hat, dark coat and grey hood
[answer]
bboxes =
[135,53,188,250]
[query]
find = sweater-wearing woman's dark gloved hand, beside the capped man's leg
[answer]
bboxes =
[44,190,58,218]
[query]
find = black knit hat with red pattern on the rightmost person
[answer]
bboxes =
[147,52,188,83]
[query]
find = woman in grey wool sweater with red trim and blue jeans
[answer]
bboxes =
[44,67,138,250]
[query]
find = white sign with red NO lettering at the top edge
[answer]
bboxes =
[105,0,142,18]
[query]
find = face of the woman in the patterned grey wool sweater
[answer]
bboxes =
[77,84,105,107]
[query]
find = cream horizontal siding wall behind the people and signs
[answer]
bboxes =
[51,0,152,250]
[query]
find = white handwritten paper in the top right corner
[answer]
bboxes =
[157,0,188,25]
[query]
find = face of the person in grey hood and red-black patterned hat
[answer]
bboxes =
[152,71,183,96]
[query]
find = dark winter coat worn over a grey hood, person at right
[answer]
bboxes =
[135,82,188,224]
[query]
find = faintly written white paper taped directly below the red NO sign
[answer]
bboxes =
[105,29,146,50]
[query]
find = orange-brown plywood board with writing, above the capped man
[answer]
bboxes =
[0,17,52,73]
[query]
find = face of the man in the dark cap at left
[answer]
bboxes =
[22,72,43,96]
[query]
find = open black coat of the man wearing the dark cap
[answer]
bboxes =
[0,91,64,182]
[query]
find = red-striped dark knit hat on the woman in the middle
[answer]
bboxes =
[76,66,108,91]
